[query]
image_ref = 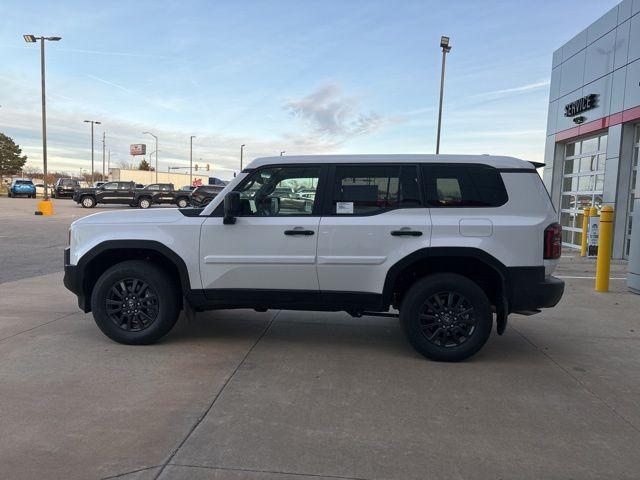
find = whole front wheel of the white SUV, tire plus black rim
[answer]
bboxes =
[91,260,180,345]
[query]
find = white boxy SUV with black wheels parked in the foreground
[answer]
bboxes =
[64,155,564,361]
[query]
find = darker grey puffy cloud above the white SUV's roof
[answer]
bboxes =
[284,84,393,141]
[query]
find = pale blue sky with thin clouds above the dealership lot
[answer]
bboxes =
[0,0,618,179]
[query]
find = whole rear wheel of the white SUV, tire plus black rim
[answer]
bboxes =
[400,273,493,362]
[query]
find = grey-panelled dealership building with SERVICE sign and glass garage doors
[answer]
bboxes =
[543,0,640,258]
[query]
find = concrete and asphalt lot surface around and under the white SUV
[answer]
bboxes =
[0,198,640,480]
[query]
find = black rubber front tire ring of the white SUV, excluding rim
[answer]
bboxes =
[91,260,180,345]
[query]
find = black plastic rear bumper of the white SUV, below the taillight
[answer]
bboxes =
[508,267,564,312]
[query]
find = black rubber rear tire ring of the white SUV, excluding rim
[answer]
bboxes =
[400,273,493,362]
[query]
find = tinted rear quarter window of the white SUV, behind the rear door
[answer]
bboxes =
[422,164,509,208]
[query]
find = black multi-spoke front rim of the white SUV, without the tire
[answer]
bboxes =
[105,278,158,332]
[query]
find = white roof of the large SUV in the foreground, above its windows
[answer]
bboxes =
[246,154,541,169]
